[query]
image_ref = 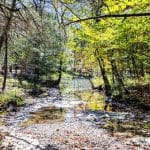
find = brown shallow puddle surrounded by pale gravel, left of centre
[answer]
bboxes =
[22,106,66,126]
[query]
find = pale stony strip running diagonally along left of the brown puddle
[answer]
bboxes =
[0,88,61,128]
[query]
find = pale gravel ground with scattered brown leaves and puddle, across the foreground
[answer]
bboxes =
[0,89,150,150]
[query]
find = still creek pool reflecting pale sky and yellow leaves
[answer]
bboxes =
[61,77,112,111]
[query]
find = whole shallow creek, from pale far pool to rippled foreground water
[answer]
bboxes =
[0,78,150,136]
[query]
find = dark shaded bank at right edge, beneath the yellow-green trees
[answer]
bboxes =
[113,84,150,113]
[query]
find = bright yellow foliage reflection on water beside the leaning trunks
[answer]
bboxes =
[76,91,112,111]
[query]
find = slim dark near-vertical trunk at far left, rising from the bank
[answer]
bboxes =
[2,35,8,91]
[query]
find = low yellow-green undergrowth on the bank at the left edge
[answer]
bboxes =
[0,88,24,106]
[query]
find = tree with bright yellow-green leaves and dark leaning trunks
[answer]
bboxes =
[66,0,149,95]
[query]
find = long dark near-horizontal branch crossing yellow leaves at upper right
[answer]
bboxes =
[65,13,150,26]
